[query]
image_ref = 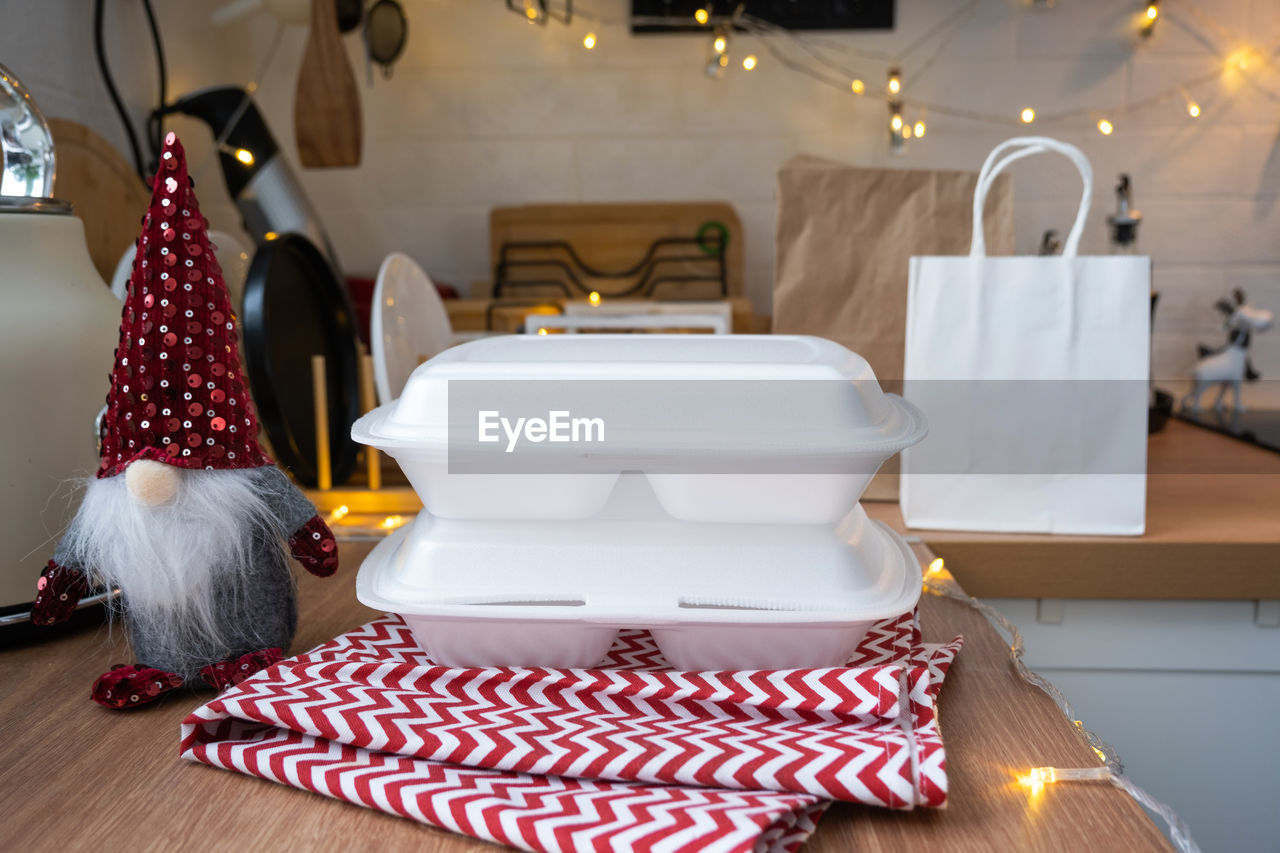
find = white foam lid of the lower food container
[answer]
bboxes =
[356,506,920,628]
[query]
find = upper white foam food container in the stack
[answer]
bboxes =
[352,334,927,524]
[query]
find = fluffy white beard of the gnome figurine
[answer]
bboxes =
[63,469,285,651]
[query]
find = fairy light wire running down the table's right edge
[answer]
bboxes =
[908,555,1201,853]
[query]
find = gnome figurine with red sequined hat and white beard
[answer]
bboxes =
[32,133,338,708]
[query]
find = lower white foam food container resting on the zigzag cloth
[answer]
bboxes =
[356,474,922,671]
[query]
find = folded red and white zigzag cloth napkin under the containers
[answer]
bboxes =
[182,613,960,852]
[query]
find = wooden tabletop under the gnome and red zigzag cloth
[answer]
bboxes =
[0,543,1169,853]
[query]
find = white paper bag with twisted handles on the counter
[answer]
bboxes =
[900,137,1151,535]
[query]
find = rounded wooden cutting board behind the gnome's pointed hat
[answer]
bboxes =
[49,119,151,284]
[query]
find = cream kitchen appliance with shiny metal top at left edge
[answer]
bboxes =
[0,67,124,624]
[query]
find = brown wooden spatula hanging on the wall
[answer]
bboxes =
[293,0,364,169]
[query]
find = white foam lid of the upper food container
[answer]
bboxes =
[352,334,927,473]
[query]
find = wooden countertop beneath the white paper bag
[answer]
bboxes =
[865,420,1280,599]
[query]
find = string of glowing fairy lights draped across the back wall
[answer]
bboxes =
[507,0,1280,152]
